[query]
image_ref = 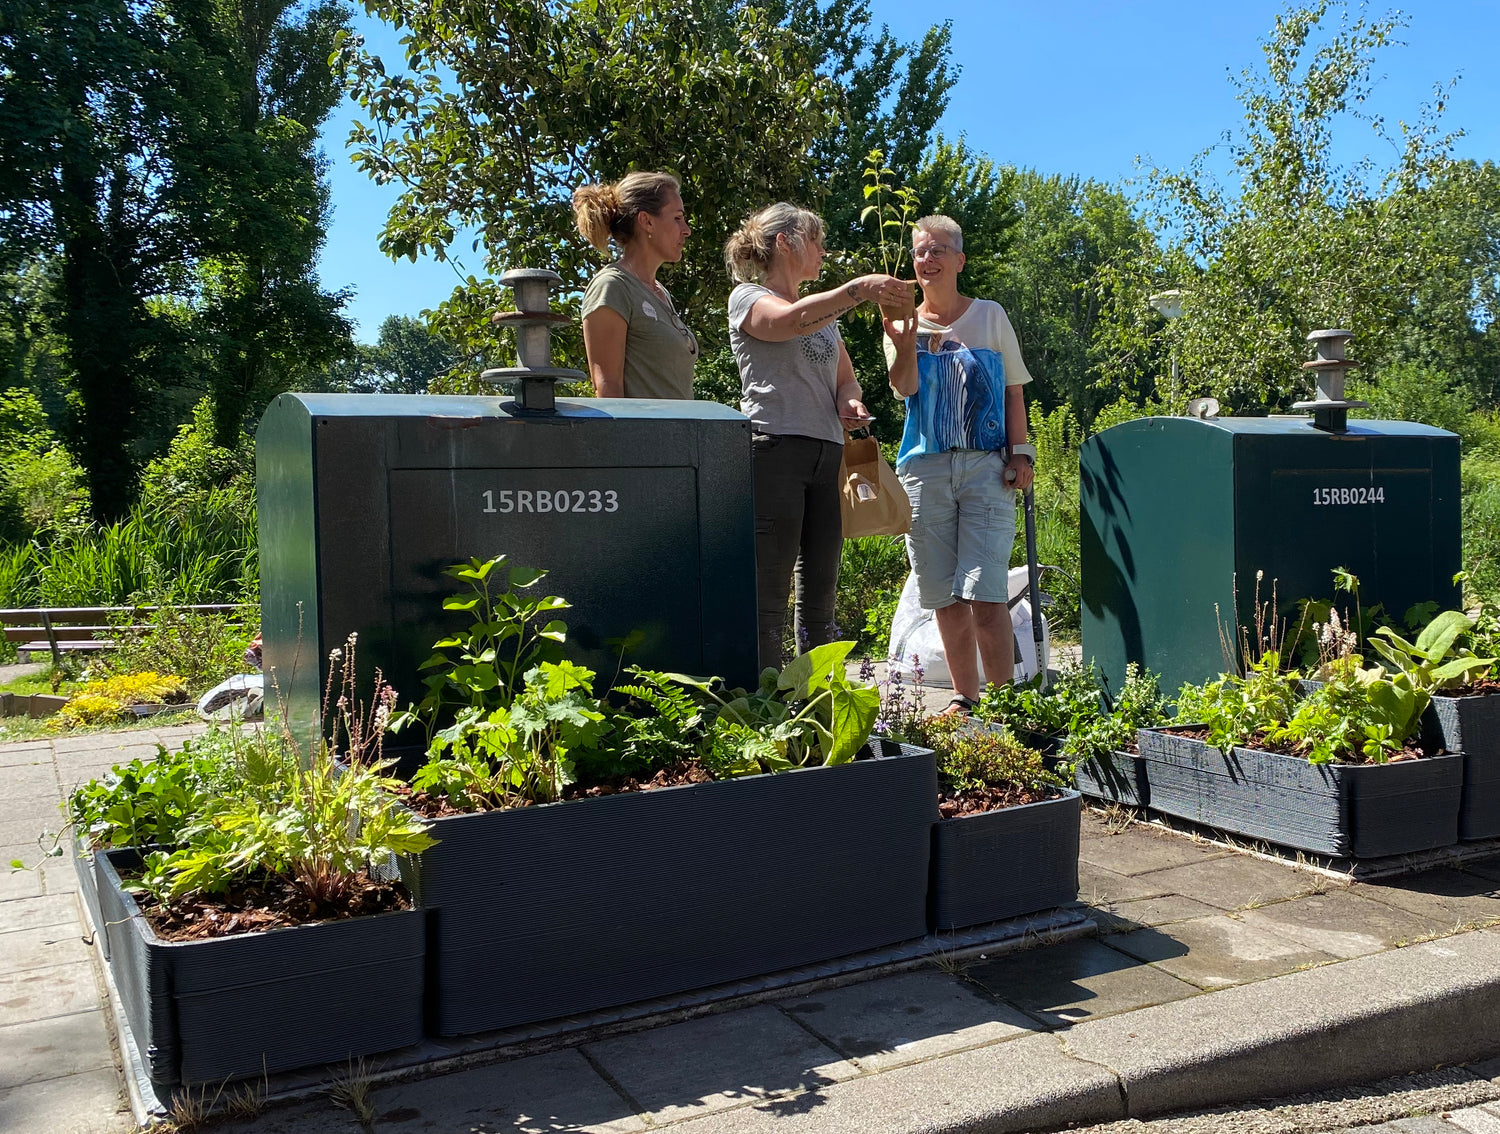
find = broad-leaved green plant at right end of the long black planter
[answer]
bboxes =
[671,642,881,776]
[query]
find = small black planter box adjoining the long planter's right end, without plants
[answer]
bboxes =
[927,791,1082,932]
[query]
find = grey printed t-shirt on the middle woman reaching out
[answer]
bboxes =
[729,284,843,444]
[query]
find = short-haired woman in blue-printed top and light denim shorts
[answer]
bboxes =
[885,216,1037,714]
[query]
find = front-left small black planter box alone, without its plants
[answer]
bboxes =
[95,851,426,1091]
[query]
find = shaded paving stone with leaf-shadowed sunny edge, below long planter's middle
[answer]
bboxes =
[584,1005,860,1124]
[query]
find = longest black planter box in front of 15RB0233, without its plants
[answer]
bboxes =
[404,741,938,1035]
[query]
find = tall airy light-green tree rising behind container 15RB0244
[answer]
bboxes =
[1136,0,1458,410]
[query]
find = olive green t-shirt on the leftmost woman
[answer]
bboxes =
[584,264,698,399]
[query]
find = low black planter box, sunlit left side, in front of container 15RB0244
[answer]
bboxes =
[1137,729,1463,858]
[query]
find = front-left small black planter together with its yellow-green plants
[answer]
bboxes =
[98,639,432,1094]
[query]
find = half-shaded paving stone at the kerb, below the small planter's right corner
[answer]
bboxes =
[968,930,1199,1028]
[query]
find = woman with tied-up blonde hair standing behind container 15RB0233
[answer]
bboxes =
[573,173,698,399]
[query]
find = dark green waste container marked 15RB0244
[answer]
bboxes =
[1079,417,1460,692]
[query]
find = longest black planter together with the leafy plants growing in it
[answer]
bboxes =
[398,557,938,1035]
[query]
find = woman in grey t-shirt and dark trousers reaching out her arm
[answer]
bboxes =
[725,201,911,666]
